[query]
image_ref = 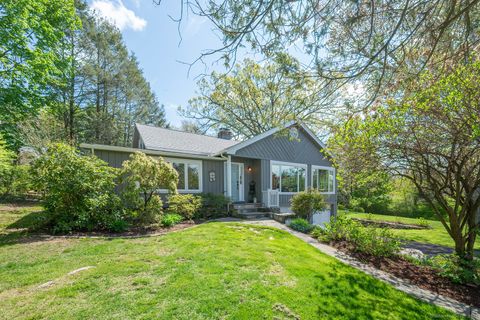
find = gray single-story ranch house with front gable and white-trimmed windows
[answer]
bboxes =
[80,122,337,219]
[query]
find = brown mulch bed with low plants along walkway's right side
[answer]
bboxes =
[330,241,480,307]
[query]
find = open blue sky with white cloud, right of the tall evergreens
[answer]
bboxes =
[89,0,232,126]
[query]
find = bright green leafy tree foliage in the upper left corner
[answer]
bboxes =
[0,0,78,145]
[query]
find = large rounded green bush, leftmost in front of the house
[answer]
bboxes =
[32,144,124,233]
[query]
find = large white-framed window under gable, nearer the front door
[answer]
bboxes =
[271,161,307,193]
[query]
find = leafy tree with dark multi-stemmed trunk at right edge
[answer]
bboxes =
[342,61,480,259]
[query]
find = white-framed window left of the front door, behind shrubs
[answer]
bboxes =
[165,159,202,192]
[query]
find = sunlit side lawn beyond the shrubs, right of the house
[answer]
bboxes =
[340,211,480,249]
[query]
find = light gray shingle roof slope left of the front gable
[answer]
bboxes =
[136,124,239,155]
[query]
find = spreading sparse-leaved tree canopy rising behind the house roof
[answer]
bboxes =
[180,54,340,138]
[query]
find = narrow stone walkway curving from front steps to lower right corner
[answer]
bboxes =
[217,218,480,320]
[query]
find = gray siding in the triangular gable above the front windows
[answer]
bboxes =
[236,129,331,166]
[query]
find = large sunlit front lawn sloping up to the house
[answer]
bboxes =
[0,205,464,320]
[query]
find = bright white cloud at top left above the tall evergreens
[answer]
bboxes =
[90,0,147,31]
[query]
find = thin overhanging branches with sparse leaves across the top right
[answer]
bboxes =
[156,0,480,106]
